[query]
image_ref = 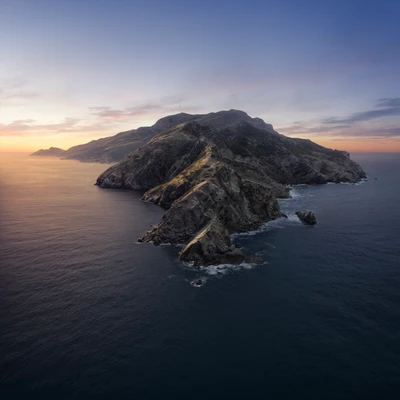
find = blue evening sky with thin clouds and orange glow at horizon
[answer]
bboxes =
[0,0,400,152]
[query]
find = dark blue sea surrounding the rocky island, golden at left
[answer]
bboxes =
[0,154,400,399]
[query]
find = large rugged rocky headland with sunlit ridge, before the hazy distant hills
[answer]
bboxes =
[96,110,366,266]
